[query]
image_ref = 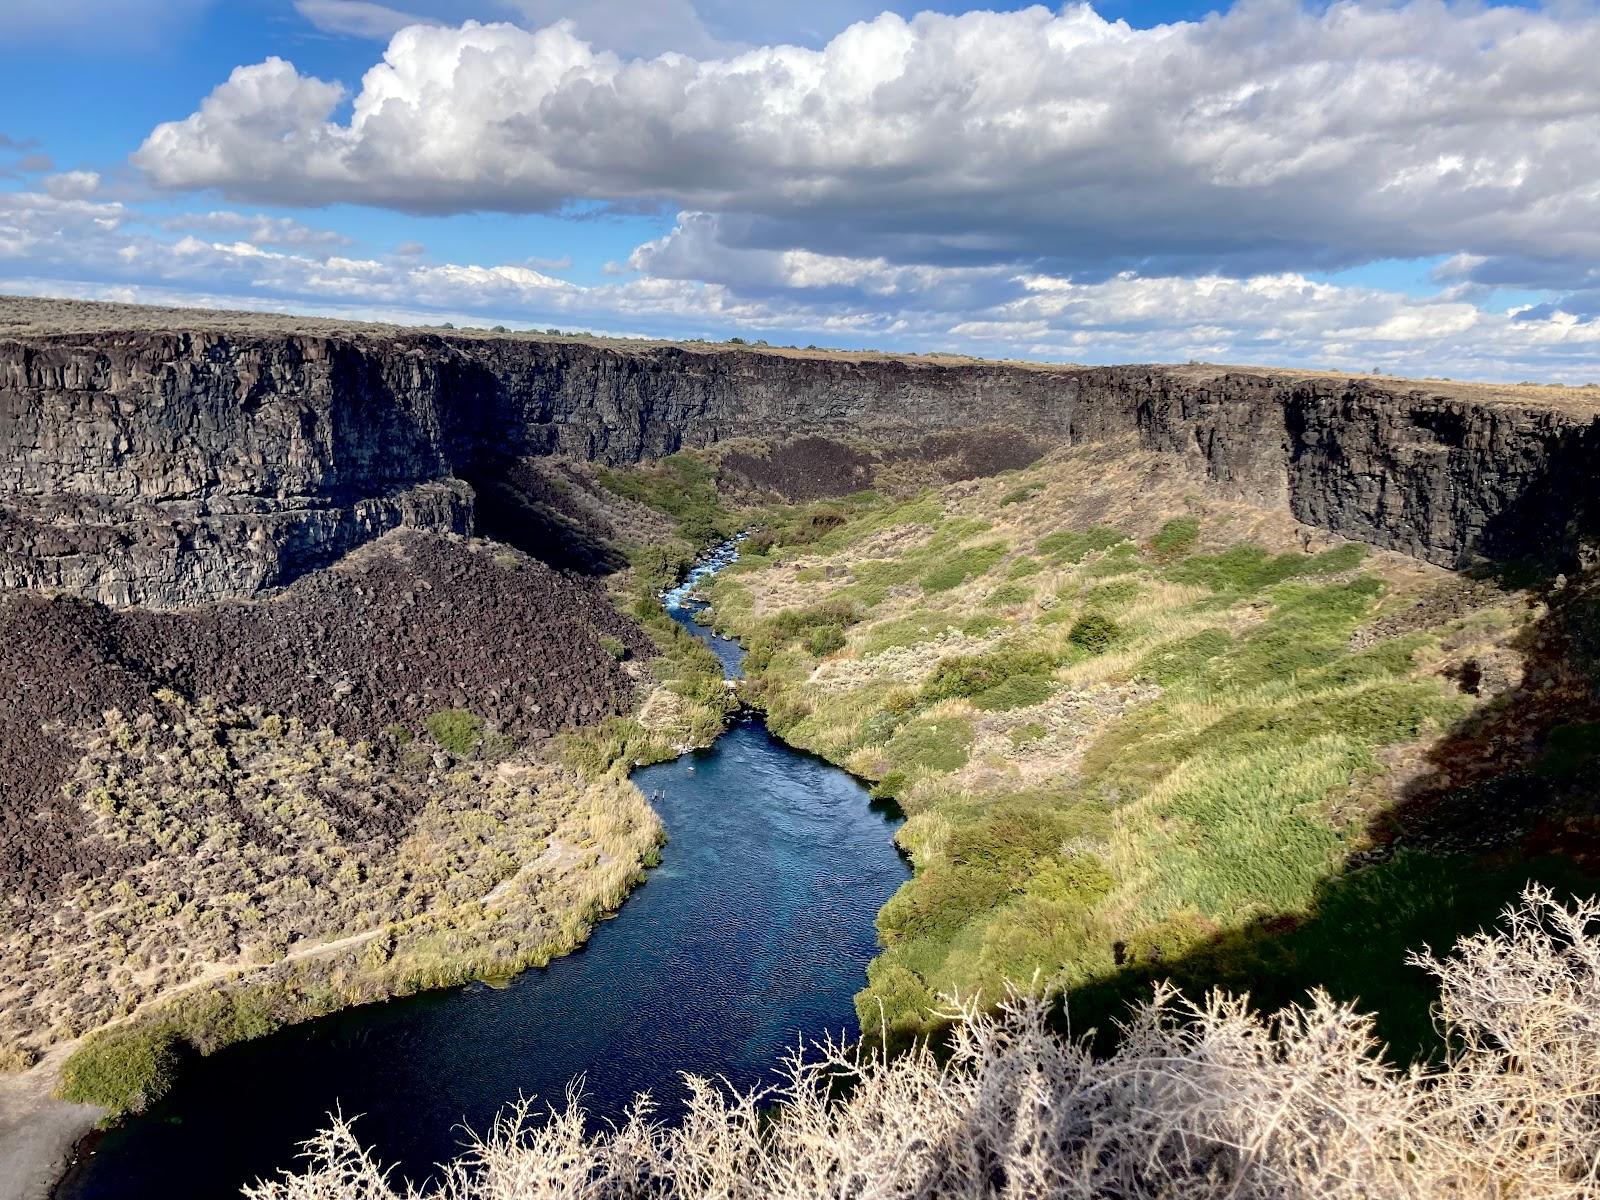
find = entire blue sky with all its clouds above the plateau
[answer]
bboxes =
[0,0,1600,384]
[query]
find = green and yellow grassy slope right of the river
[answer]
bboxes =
[714,448,1600,1048]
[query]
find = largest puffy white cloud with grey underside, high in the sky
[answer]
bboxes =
[136,0,1600,275]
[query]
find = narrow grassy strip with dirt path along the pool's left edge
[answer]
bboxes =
[0,762,662,1200]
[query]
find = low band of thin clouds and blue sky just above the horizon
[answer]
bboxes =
[9,173,1600,382]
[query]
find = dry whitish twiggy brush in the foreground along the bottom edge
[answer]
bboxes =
[246,890,1600,1200]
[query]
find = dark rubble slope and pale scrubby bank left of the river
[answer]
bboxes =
[0,533,700,1200]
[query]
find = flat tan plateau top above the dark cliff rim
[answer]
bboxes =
[9,296,1600,416]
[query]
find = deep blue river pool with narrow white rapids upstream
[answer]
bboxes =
[58,546,907,1200]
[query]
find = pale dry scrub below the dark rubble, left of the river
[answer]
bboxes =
[0,693,659,1053]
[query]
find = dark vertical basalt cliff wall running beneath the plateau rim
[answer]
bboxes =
[0,321,1600,608]
